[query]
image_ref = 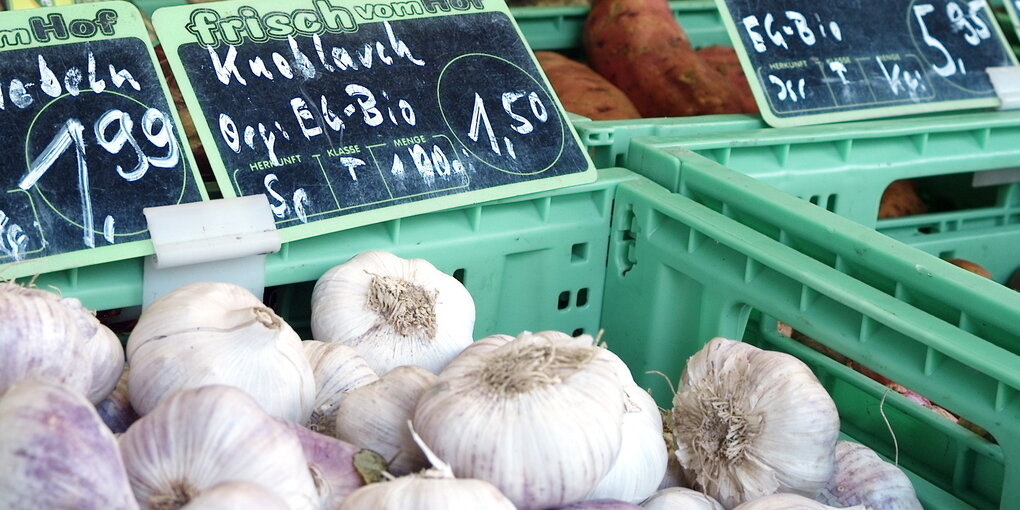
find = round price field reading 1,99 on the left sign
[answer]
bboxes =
[24,89,188,238]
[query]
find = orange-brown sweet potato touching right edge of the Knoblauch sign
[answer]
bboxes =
[534,51,641,120]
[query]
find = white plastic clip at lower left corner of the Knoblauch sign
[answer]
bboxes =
[142,194,281,307]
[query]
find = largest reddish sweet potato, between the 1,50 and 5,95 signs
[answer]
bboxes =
[582,0,743,117]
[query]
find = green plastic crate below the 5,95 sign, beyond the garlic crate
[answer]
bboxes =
[628,111,1020,283]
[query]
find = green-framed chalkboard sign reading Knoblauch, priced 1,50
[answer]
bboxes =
[154,0,596,241]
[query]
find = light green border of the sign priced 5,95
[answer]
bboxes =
[715,0,1017,128]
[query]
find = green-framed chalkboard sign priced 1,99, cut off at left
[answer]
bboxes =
[0,2,205,278]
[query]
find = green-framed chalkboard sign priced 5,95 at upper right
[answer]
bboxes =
[716,0,1017,126]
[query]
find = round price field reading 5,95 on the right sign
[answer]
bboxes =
[907,0,999,94]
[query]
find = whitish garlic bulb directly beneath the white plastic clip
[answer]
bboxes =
[128,283,315,423]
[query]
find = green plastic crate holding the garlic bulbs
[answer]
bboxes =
[21,161,1020,509]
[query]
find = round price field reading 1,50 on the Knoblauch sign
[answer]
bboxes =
[436,53,567,175]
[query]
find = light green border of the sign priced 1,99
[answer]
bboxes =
[0,0,209,279]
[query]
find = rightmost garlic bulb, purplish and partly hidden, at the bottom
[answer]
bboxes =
[817,441,921,510]
